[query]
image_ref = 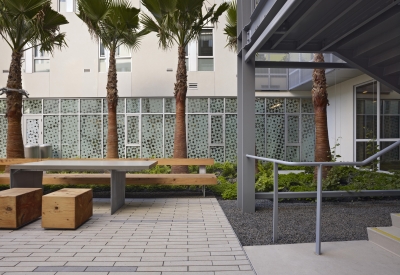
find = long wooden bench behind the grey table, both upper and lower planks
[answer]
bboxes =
[0,159,217,196]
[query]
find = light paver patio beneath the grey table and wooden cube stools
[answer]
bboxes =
[0,198,255,275]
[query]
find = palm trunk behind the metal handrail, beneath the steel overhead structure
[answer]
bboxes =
[311,53,332,179]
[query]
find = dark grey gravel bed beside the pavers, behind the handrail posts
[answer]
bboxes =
[218,199,400,246]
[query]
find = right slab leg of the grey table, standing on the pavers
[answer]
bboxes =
[110,170,126,214]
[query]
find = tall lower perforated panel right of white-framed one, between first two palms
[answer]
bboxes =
[43,115,61,158]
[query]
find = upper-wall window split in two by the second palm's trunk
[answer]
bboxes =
[99,43,132,73]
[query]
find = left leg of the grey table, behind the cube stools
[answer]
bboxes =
[10,169,43,188]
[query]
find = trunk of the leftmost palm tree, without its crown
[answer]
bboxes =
[6,51,24,158]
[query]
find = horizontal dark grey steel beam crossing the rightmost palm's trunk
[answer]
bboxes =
[255,61,353,69]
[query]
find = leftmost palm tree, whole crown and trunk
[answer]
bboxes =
[0,0,68,158]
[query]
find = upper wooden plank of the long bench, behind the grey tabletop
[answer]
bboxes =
[0,158,214,167]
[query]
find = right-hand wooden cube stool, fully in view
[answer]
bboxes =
[42,188,93,229]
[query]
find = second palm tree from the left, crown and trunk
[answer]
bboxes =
[77,0,147,158]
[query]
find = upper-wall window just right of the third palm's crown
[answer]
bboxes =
[197,29,214,71]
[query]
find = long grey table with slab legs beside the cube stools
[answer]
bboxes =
[10,160,157,214]
